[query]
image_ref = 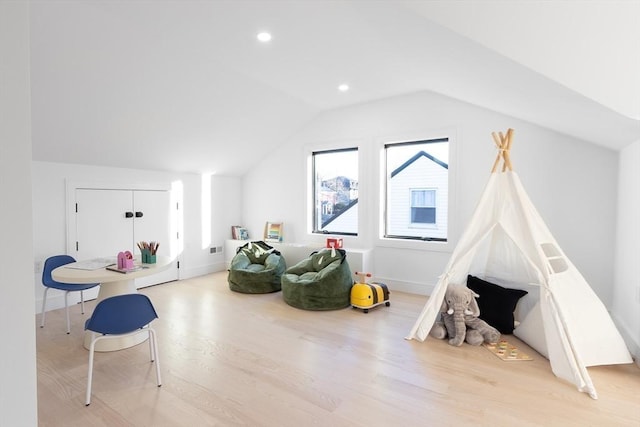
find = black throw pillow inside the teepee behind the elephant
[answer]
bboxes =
[467,275,528,334]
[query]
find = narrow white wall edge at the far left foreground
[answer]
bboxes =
[0,2,38,426]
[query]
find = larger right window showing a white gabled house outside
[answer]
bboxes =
[384,138,449,242]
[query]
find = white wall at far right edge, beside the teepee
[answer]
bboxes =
[613,141,640,364]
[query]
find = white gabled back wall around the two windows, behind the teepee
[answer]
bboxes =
[243,92,618,305]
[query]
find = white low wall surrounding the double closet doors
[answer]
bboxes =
[31,161,241,312]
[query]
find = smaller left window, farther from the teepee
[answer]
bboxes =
[312,148,358,236]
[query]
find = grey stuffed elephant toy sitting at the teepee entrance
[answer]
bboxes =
[429,285,500,346]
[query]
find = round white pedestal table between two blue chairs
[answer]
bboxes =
[51,256,173,351]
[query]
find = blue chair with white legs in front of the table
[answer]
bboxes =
[84,294,162,406]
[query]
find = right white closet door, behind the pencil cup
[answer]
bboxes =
[133,190,178,288]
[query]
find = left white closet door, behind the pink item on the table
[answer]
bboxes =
[74,189,134,261]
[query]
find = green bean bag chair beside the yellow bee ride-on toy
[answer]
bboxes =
[282,249,353,310]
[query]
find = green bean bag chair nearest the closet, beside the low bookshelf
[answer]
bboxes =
[228,241,287,294]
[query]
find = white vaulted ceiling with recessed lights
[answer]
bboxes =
[31,0,640,175]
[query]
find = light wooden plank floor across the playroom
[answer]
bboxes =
[36,272,640,427]
